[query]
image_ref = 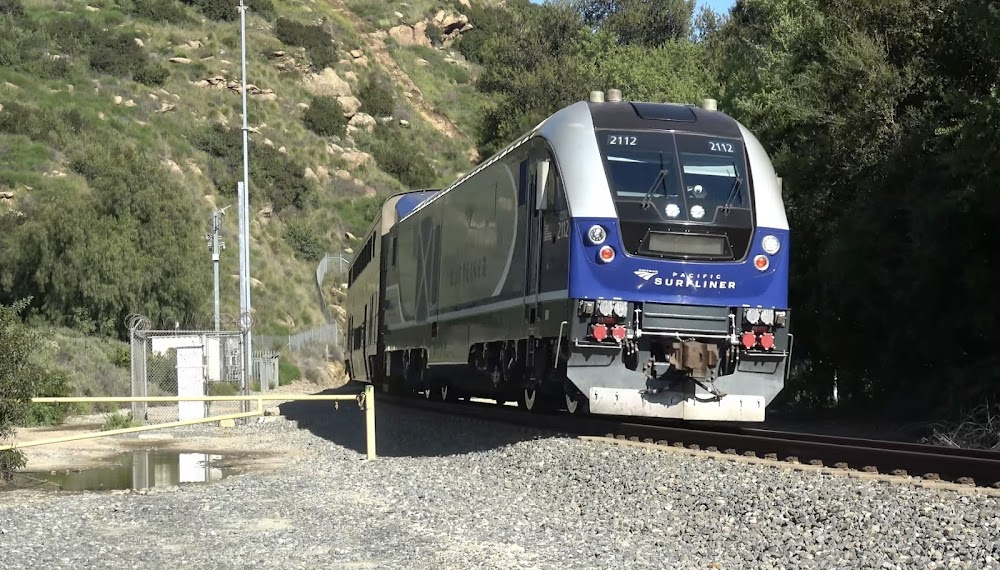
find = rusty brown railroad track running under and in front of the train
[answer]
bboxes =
[377,394,1000,489]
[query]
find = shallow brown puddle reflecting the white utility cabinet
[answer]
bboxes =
[25,450,239,491]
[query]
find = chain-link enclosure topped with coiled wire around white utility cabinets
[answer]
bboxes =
[128,310,252,424]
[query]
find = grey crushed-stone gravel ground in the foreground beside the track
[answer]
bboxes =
[0,390,1000,570]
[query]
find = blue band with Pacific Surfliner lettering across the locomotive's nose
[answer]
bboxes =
[569,218,789,309]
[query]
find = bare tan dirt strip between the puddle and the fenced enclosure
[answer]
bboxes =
[5,380,332,472]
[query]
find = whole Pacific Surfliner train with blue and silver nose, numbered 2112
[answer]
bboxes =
[344,90,794,422]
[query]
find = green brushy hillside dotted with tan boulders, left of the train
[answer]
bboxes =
[0,0,488,344]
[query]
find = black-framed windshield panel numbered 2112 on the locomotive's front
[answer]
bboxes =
[597,129,753,259]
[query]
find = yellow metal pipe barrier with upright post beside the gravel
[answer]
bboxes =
[0,384,375,459]
